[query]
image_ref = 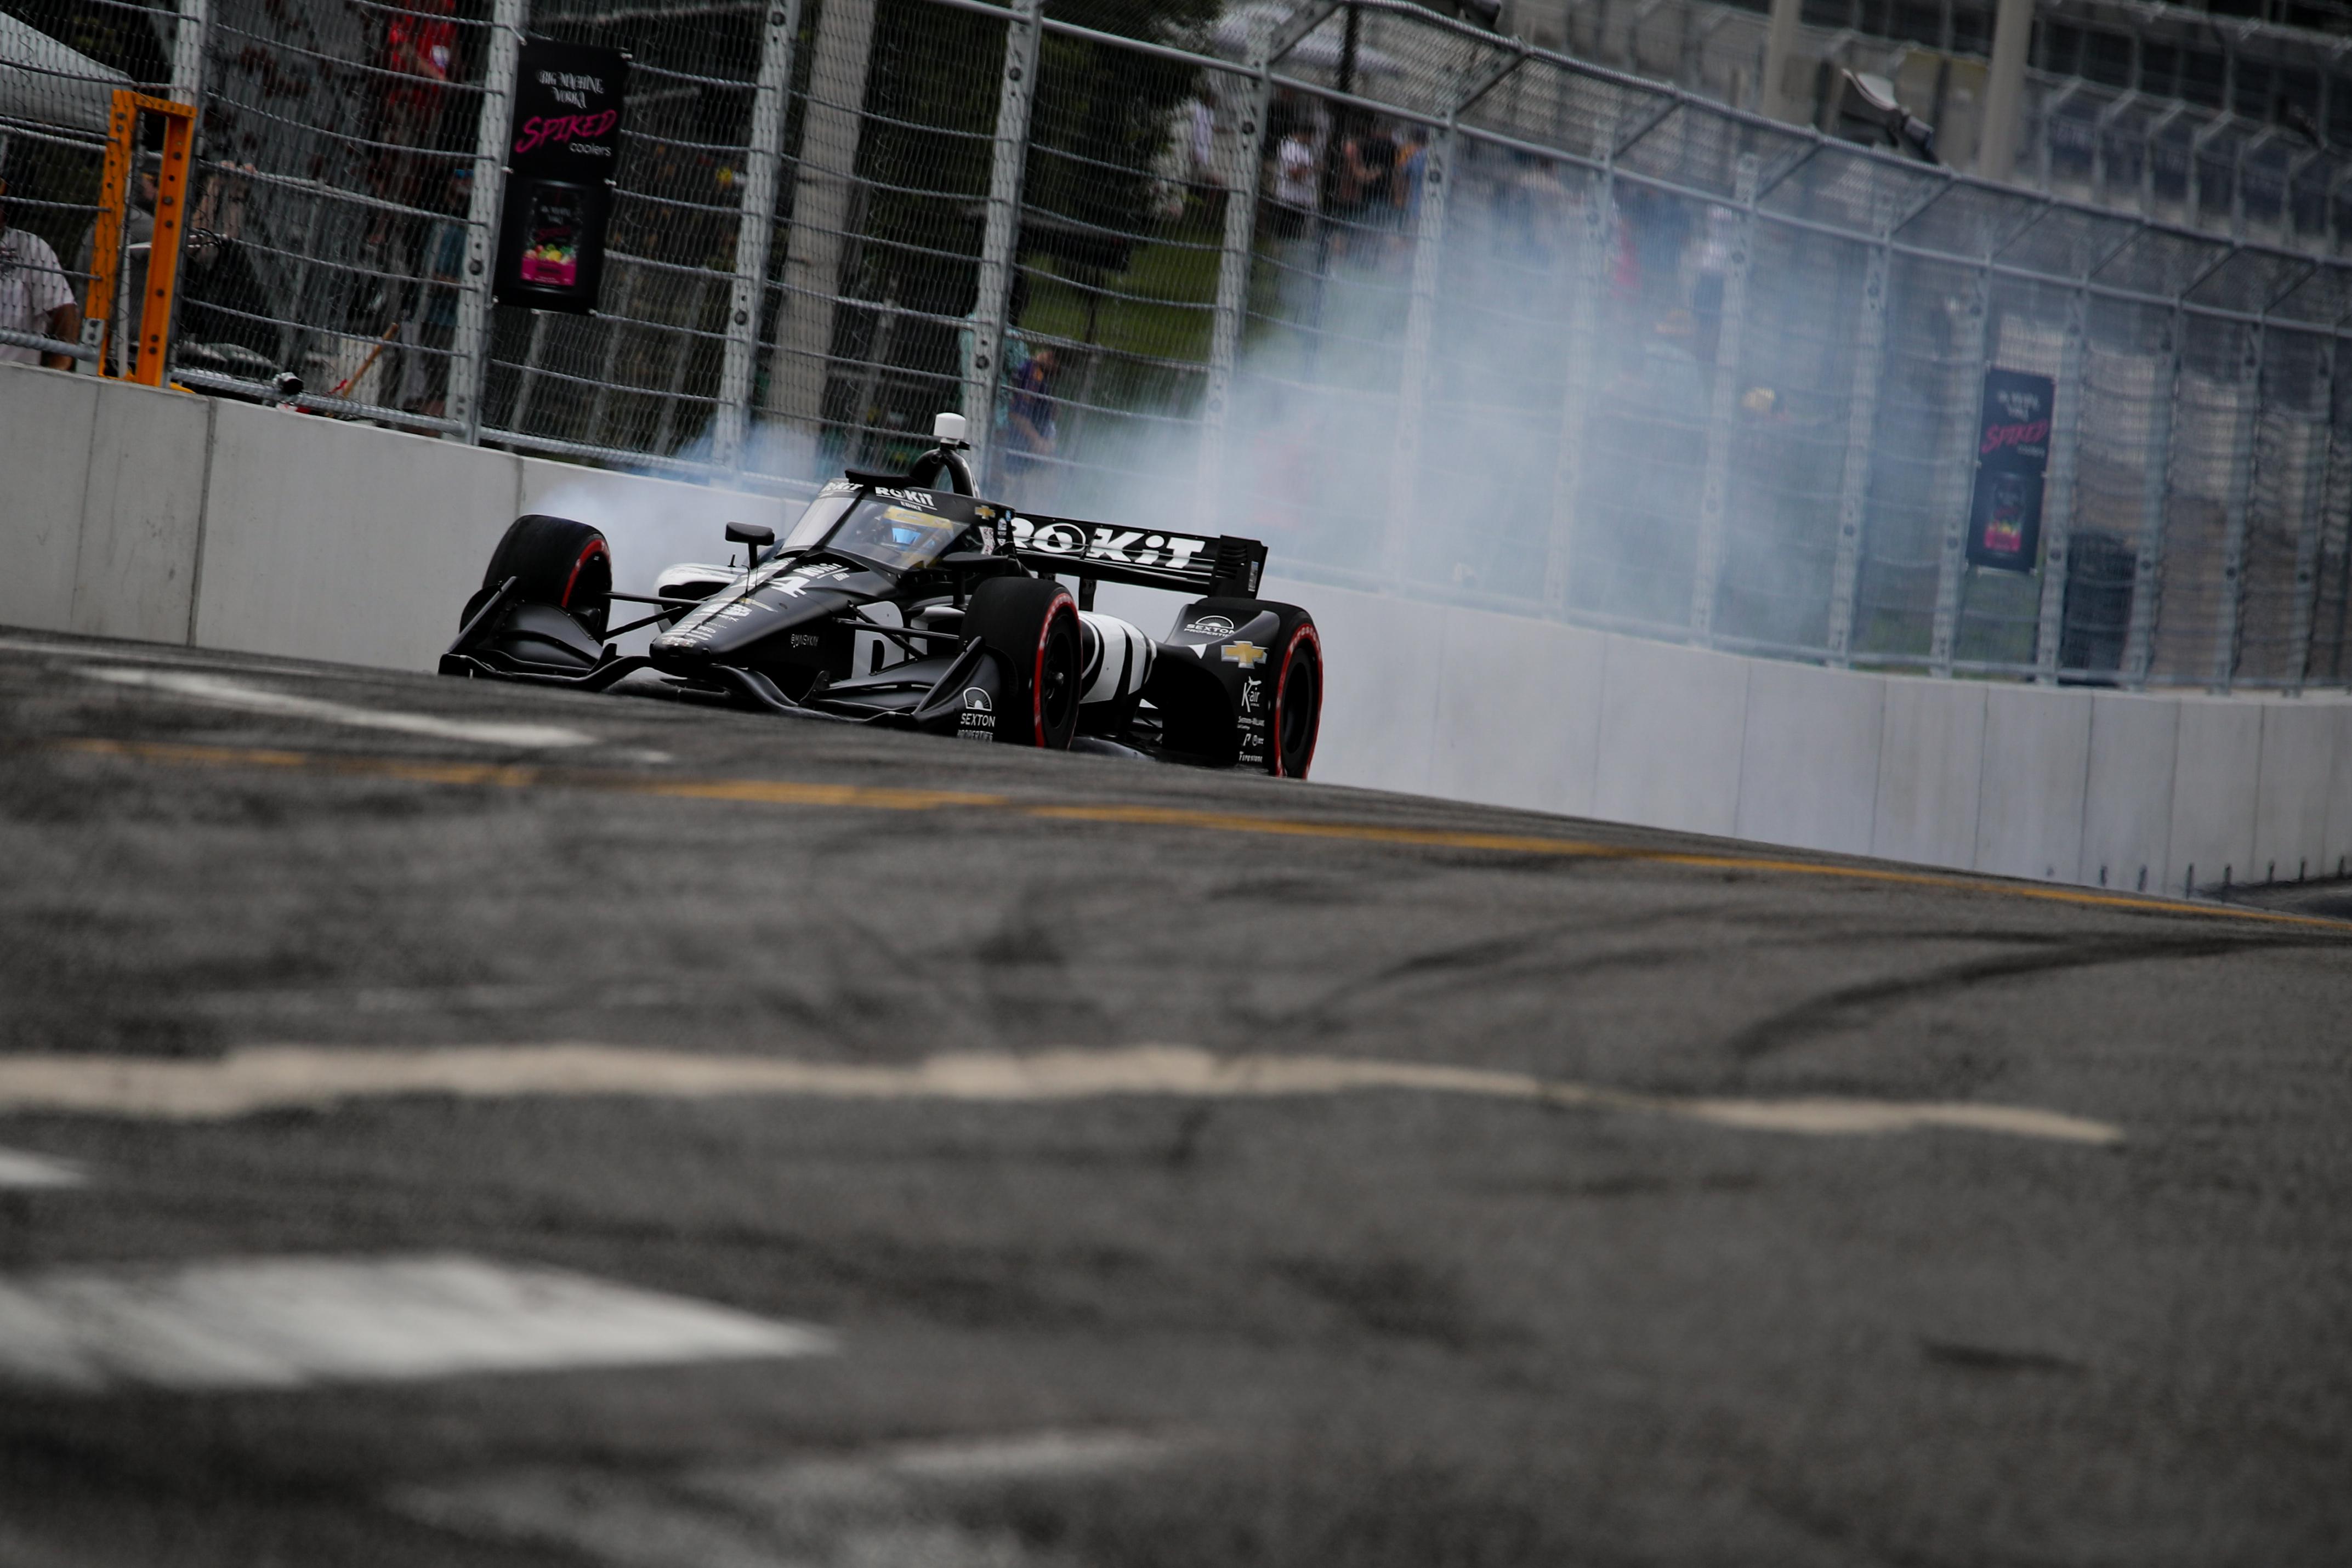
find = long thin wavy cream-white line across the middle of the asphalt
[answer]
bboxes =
[0,1046,2124,1143]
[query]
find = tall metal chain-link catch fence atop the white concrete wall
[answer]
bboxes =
[14,0,2352,686]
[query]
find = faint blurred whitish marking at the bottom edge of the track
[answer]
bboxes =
[404,1431,1171,1568]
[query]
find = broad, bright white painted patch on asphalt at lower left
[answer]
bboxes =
[0,1255,833,1389]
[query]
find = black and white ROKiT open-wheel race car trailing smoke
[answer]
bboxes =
[440,414,1322,778]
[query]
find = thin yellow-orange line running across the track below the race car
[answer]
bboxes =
[52,741,2352,931]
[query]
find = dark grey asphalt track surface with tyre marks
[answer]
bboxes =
[0,632,2352,1568]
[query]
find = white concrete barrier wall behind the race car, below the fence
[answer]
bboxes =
[14,367,2352,891]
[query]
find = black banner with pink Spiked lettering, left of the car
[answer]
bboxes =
[492,38,628,313]
